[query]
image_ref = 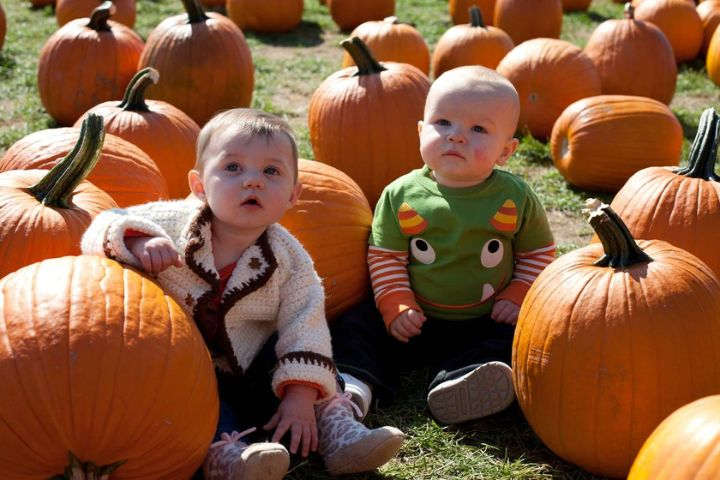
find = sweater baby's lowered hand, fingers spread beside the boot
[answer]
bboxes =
[263,385,318,457]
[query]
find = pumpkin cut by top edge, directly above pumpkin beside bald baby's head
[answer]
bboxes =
[493,0,562,45]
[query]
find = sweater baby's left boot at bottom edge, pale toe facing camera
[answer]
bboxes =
[203,428,290,480]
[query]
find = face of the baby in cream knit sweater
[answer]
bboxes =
[194,131,301,235]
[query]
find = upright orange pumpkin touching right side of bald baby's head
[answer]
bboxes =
[497,38,600,139]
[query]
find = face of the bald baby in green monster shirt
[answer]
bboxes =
[418,88,518,187]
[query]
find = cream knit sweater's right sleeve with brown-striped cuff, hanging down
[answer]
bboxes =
[272,226,336,402]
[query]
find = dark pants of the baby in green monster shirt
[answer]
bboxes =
[330,299,515,402]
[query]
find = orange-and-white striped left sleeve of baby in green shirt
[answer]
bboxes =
[368,245,421,327]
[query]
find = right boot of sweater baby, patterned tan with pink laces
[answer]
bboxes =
[316,394,405,475]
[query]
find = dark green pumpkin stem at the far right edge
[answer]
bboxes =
[675,108,720,182]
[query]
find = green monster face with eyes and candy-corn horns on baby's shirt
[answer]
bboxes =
[397,199,518,315]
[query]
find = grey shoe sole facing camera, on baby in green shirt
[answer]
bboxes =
[427,362,515,424]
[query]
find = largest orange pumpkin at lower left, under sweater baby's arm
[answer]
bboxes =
[0,255,218,479]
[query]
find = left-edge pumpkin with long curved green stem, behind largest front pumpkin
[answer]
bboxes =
[0,116,117,278]
